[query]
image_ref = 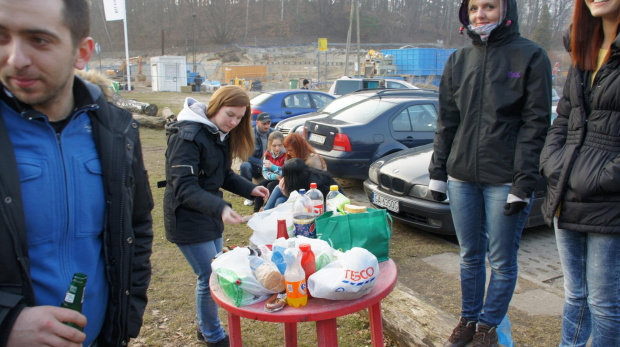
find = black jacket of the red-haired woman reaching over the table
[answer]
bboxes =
[164,121,256,244]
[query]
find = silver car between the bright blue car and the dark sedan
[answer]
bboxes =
[275,92,388,136]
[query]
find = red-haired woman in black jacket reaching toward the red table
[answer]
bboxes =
[164,86,269,347]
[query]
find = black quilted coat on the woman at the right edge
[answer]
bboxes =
[540,29,620,233]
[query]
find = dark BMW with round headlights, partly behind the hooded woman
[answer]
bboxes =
[364,143,546,235]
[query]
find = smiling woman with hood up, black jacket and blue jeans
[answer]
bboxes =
[429,0,551,347]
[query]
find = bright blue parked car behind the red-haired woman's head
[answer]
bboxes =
[250,89,335,126]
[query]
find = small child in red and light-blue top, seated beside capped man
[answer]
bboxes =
[254,130,286,212]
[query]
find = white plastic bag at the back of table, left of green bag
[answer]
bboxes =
[248,191,299,246]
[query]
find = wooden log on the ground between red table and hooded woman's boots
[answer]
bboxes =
[381,283,458,346]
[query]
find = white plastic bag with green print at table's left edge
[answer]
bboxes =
[211,247,275,307]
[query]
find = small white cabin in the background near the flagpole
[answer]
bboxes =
[151,55,187,92]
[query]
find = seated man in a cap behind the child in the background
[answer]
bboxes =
[239,112,273,206]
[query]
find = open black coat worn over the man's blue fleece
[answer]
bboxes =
[0,78,153,346]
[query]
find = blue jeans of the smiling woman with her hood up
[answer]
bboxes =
[448,180,531,327]
